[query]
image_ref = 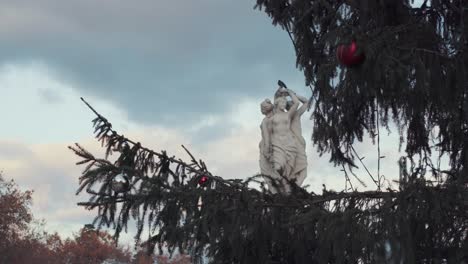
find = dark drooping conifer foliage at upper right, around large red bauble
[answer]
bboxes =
[256,0,468,181]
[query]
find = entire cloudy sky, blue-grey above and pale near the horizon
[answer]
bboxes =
[0,0,416,246]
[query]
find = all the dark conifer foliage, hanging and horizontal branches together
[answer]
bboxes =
[70,0,468,264]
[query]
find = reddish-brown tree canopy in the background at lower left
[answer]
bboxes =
[0,173,190,264]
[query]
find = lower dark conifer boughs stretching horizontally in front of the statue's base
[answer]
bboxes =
[70,97,468,264]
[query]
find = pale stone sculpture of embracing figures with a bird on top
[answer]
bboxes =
[259,81,309,193]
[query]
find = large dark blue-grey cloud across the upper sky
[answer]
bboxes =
[0,0,303,127]
